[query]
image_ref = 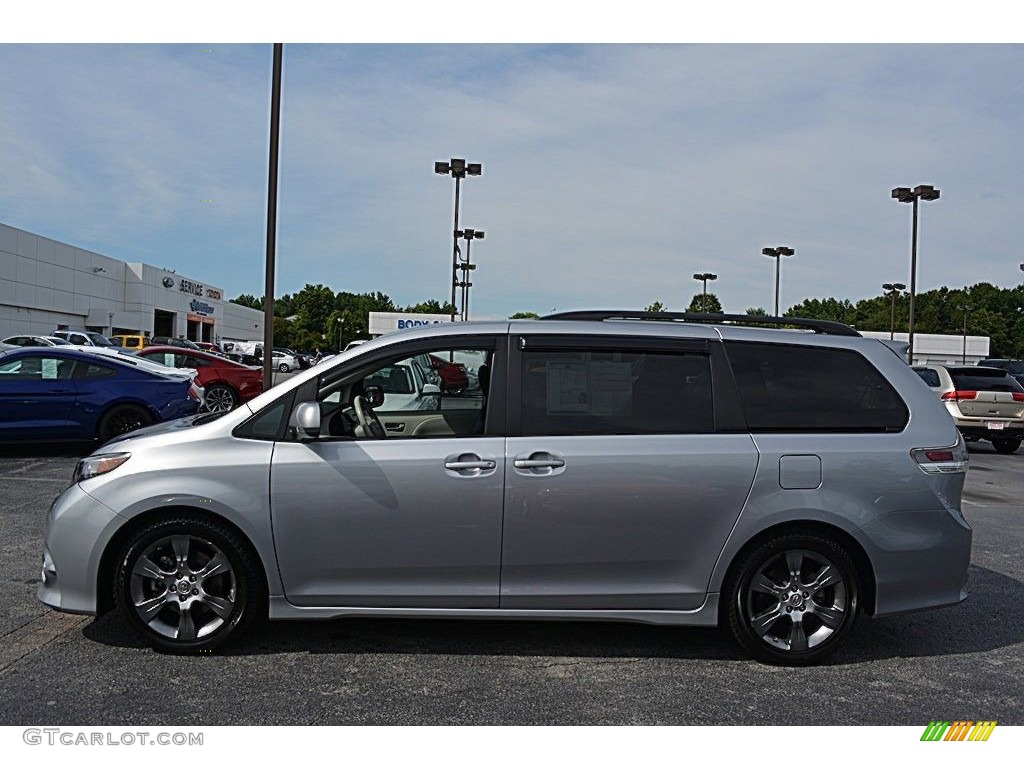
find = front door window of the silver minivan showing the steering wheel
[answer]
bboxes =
[317,348,493,439]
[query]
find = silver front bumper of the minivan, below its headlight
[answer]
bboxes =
[36,484,124,615]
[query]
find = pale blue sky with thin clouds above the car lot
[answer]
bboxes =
[0,41,1024,317]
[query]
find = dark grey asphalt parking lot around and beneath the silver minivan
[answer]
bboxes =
[0,444,1024,726]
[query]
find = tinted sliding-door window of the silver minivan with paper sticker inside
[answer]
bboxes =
[520,349,714,435]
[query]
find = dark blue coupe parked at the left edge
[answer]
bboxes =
[0,347,200,442]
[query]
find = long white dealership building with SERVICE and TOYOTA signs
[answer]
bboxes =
[0,224,263,343]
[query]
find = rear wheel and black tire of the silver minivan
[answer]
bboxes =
[723,532,860,667]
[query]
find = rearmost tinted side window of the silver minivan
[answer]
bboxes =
[725,342,909,432]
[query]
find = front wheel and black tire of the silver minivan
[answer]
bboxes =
[114,514,266,653]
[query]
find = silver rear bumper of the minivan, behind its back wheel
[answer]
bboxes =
[858,509,973,616]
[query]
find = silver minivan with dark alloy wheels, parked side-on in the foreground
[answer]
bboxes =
[39,311,972,665]
